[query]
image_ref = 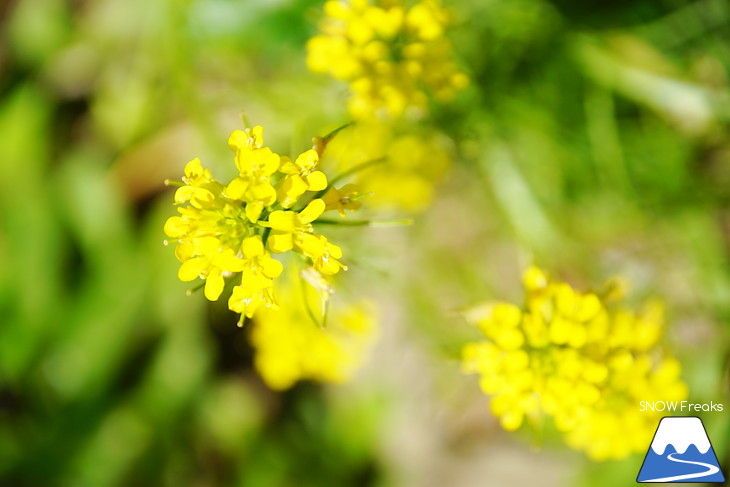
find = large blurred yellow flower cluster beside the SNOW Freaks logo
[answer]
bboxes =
[462,267,687,460]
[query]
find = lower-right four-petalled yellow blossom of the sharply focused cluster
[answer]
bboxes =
[260,198,345,274]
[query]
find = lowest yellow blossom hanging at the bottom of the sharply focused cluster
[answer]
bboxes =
[228,235,283,318]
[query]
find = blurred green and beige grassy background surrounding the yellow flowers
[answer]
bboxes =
[0,0,730,487]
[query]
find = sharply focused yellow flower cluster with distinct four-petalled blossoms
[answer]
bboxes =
[164,126,355,323]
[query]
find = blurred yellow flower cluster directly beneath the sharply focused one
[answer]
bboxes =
[251,275,376,390]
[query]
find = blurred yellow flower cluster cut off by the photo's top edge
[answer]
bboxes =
[307,0,468,120]
